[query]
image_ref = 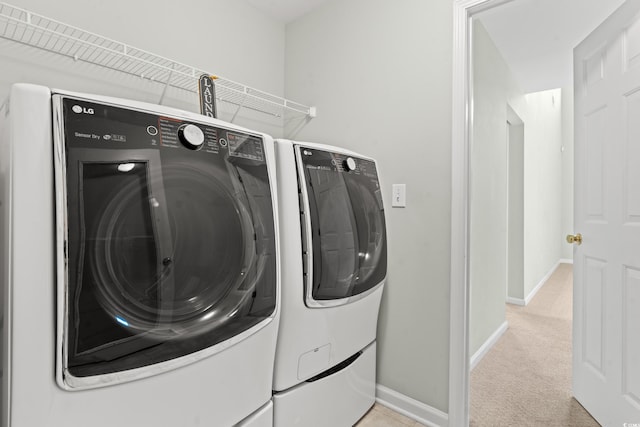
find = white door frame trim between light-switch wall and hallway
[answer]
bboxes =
[448,0,516,427]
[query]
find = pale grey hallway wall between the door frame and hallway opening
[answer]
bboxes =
[469,20,528,355]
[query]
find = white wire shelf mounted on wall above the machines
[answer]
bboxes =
[0,2,316,118]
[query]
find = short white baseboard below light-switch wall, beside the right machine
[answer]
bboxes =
[376,384,449,427]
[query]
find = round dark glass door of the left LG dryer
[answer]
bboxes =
[88,161,256,340]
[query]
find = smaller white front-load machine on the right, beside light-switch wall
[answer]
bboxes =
[274,140,387,427]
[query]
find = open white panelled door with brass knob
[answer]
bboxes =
[573,0,640,427]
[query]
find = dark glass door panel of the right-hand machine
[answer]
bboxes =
[296,146,387,307]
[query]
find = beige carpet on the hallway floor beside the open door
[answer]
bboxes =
[470,264,599,427]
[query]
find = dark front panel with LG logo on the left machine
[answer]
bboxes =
[58,98,276,389]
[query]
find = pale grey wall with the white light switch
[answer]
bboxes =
[285,0,453,412]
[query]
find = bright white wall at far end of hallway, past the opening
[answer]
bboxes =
[524,89,563,298]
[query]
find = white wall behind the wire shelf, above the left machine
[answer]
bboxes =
[0,0,285,136]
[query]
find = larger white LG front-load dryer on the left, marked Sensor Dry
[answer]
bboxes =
[0,85,279,427]
